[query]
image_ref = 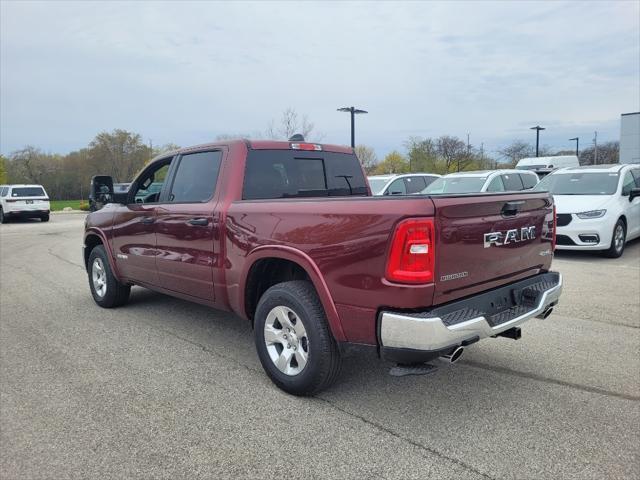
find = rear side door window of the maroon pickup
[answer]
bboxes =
[169,150,222,203]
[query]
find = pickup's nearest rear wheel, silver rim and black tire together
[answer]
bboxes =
[254,280,341,395]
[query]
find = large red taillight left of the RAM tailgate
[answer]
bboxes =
[386,218,435,283]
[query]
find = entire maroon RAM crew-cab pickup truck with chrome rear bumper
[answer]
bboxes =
[84,141,562,395]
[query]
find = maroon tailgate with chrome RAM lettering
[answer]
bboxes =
[431,192,553,305]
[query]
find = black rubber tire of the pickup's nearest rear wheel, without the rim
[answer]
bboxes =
[254,280,341,396]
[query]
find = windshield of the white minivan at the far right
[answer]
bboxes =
[534,172,619,195]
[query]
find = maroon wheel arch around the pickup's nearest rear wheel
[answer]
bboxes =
[239,245,346,341]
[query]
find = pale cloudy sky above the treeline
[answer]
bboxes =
[0,0,640,158]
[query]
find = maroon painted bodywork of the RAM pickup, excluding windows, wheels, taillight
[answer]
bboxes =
[85,141,553,345]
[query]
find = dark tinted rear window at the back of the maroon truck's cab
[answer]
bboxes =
[242,150,368,200]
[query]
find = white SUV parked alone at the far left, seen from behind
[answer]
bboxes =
[0,185,51,223]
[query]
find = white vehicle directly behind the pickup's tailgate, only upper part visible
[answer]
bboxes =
[422,170,538,194]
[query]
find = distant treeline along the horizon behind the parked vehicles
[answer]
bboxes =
[0,124,619,200]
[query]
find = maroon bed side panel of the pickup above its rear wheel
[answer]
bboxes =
[225,197,434,343]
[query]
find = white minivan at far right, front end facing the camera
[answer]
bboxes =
[535,164,640,258]
